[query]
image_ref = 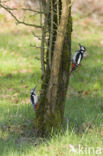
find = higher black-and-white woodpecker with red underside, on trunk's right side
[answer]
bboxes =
[70,43,86,74]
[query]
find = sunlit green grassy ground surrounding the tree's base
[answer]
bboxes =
[0,19,103,156]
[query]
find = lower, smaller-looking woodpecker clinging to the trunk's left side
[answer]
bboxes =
[30,87,38,110]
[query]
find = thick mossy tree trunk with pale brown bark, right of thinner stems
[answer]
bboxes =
[35,0,72,136]
